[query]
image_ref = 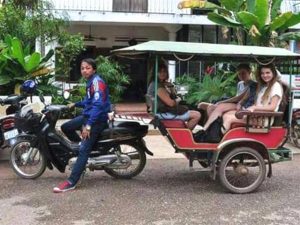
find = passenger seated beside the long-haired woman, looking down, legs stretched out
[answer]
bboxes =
[198,64,256,130]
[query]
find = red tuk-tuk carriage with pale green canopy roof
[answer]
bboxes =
[112,41,300,193]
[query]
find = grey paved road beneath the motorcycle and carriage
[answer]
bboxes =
[0,155,300,225]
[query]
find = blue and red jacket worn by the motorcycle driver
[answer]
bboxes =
[75,74,111,126]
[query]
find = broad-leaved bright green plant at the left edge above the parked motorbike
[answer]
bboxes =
[0,36,54,92]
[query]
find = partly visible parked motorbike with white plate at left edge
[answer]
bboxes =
[0,95,26,149]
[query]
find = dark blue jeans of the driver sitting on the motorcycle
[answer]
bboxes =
[62,116,108,184]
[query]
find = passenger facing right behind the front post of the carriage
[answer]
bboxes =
[147,64,201,130]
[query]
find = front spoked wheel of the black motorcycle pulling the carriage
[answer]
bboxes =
[10,140,46,179]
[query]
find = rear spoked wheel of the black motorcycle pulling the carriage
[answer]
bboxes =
[104,144,146,179]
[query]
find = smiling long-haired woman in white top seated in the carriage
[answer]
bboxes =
[223,64,283,132]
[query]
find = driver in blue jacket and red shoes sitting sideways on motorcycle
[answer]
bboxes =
[53,58,111,193]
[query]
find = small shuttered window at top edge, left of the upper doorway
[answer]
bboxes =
[113,0,148,12]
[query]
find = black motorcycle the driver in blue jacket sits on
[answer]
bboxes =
[10,99,153,179]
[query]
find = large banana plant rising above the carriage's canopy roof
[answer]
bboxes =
[179,0,300,46]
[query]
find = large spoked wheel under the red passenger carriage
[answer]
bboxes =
[219,147,266,194]
